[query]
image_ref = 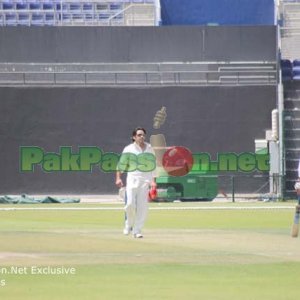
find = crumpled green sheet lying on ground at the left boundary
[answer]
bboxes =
[0,195,80,204]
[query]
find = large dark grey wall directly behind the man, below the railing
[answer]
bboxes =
[0,86,276,194]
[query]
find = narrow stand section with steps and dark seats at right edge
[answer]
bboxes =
[278,0,300,197]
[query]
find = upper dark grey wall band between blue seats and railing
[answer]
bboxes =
[0,26,276,63]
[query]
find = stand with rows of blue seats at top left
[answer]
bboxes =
[0,0,160,26]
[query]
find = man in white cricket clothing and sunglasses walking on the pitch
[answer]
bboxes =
[116,127,156,238]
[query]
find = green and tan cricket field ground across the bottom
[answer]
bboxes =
[0,203,300,300]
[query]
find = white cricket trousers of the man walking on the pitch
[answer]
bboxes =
[125,177,149,234]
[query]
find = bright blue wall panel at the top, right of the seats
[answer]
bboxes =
[161,0,275,25]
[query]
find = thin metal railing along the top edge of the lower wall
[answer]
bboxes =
[0,71,277,85]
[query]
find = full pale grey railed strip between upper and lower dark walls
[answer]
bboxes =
[0,62,278,86]
